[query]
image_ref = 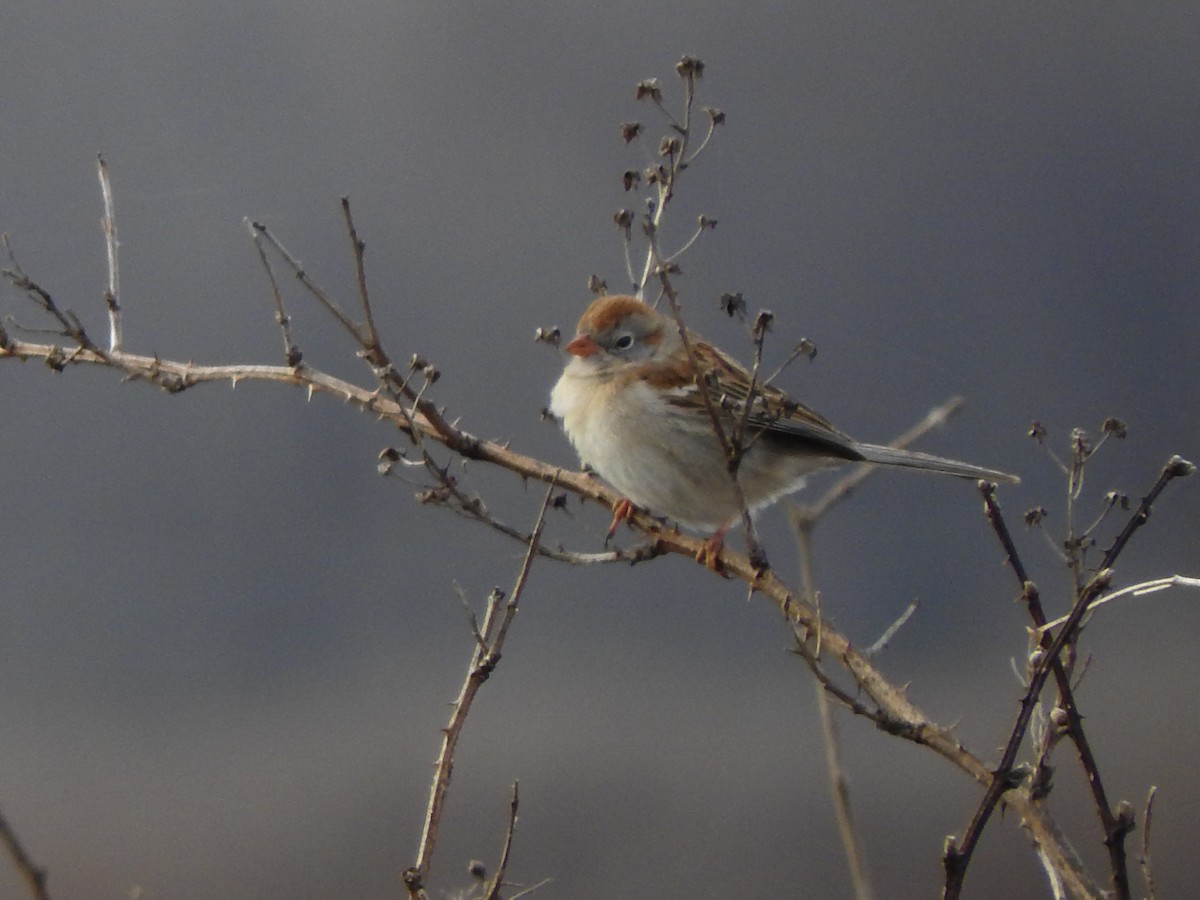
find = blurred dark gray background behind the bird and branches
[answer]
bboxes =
[0,0,1200,900]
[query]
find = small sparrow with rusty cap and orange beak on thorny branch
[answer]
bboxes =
[550,294,1020,568]
